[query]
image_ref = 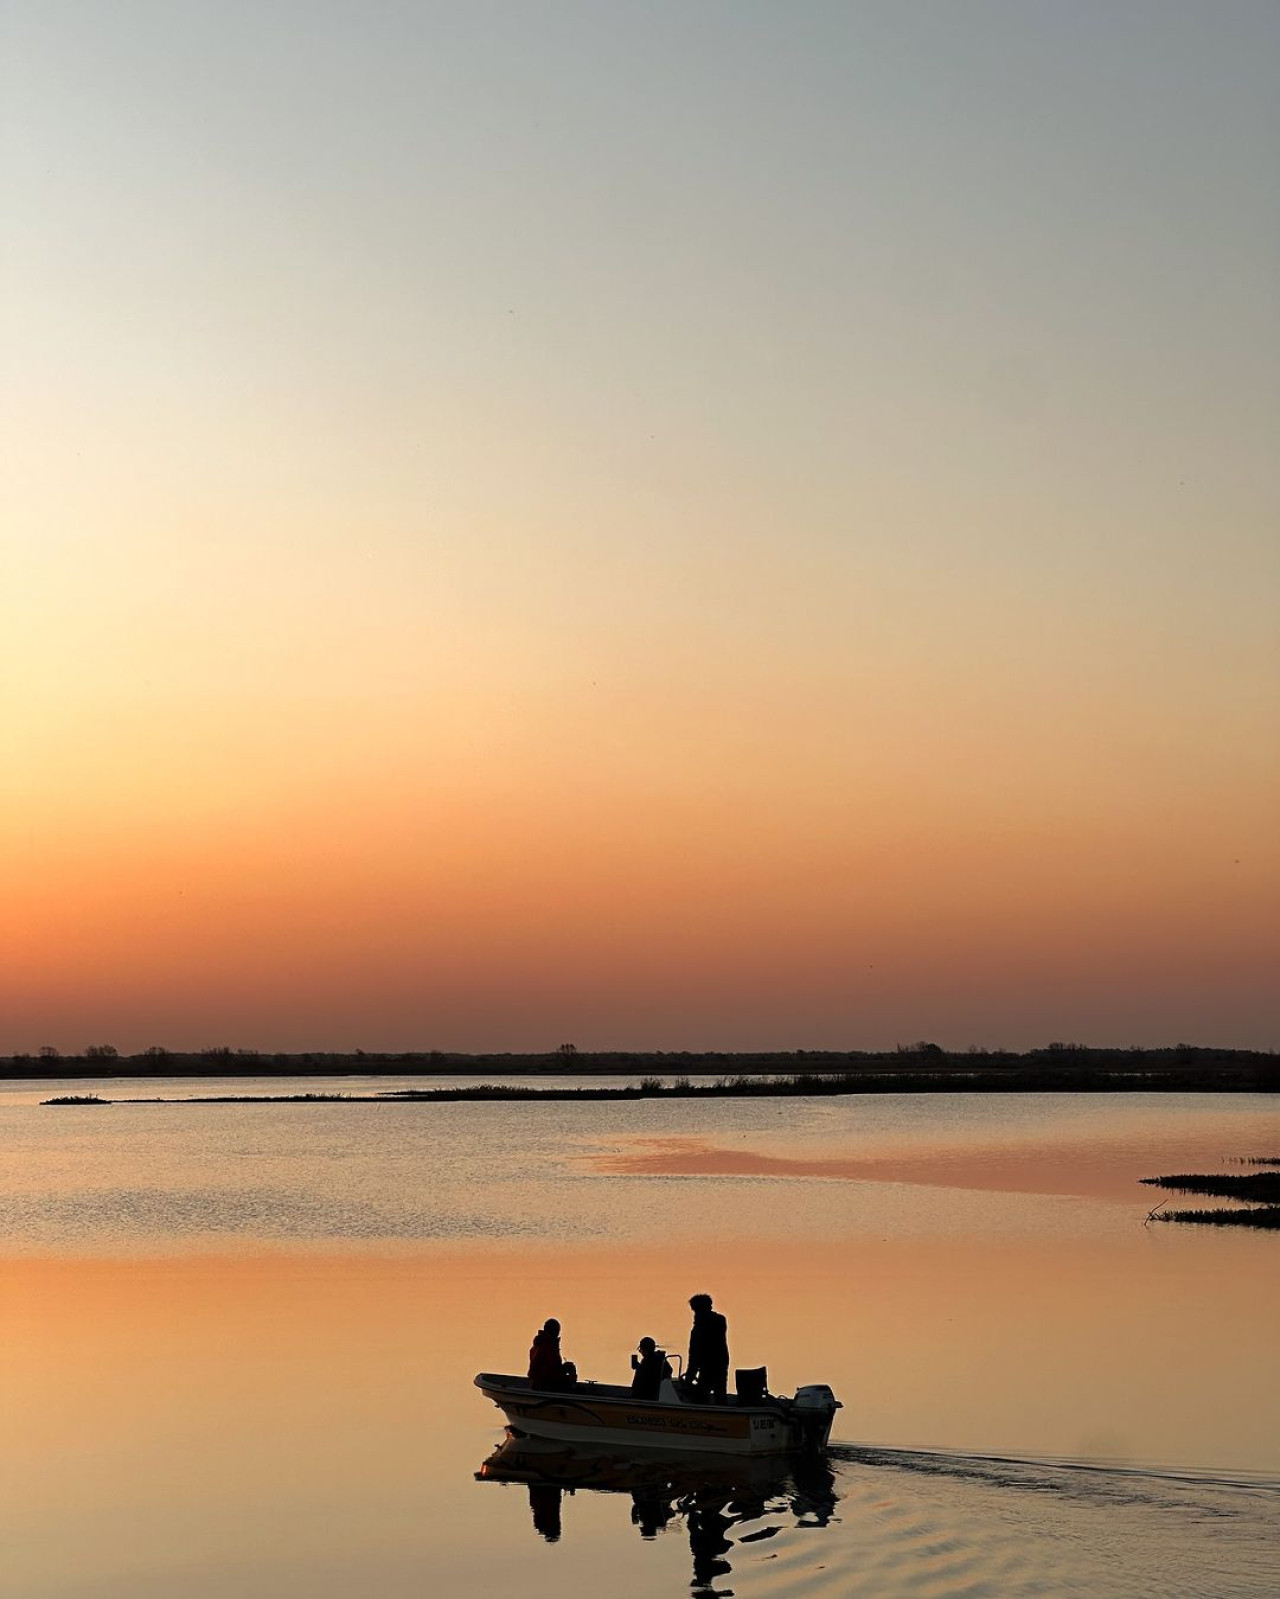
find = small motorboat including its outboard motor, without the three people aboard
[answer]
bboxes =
[475,1370,842,1455]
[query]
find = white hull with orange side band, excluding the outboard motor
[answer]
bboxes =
[476,1372,799,1455]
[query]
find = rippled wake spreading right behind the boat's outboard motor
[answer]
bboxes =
[613,1450,1280,1599]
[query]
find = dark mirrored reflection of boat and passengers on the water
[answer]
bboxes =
[476,1431,839,1593]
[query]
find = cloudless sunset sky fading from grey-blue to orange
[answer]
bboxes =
[0,0,1280,1051]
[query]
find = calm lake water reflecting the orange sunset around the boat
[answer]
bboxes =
[0,1079,1280,1599]
